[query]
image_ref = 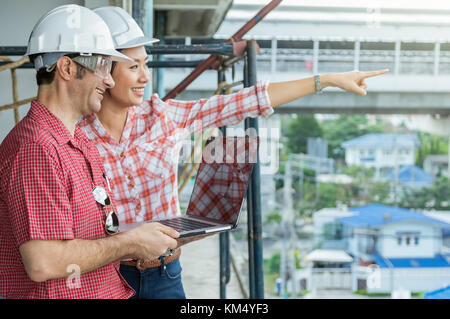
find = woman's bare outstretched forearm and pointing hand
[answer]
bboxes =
[267,69,389,107]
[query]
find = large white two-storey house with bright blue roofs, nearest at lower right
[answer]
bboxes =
[338,204,450,292]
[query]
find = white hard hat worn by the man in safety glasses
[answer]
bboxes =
[26,4,131,69]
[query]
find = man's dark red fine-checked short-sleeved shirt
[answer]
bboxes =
[0,101,133,298]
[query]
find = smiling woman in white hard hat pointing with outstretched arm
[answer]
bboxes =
[80,7,387,298]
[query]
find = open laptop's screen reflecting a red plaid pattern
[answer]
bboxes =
[186,136,259,227]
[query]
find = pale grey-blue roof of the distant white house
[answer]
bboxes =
[342,133,420,148]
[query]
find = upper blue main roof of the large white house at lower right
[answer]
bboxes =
[338,204,450,229]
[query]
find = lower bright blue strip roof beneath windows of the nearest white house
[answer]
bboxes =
[372,254,450,268]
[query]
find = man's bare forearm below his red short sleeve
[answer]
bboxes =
[20,234,134,282]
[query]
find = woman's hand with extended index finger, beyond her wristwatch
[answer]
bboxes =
[320,69,389,96]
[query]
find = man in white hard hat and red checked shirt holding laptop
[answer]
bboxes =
[0,5,178,298]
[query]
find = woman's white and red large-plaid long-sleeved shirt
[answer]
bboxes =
[80,82,273,223]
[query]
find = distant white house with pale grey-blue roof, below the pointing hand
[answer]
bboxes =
[342,133,420,176]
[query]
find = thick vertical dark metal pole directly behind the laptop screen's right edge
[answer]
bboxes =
[245,40,264,299]
